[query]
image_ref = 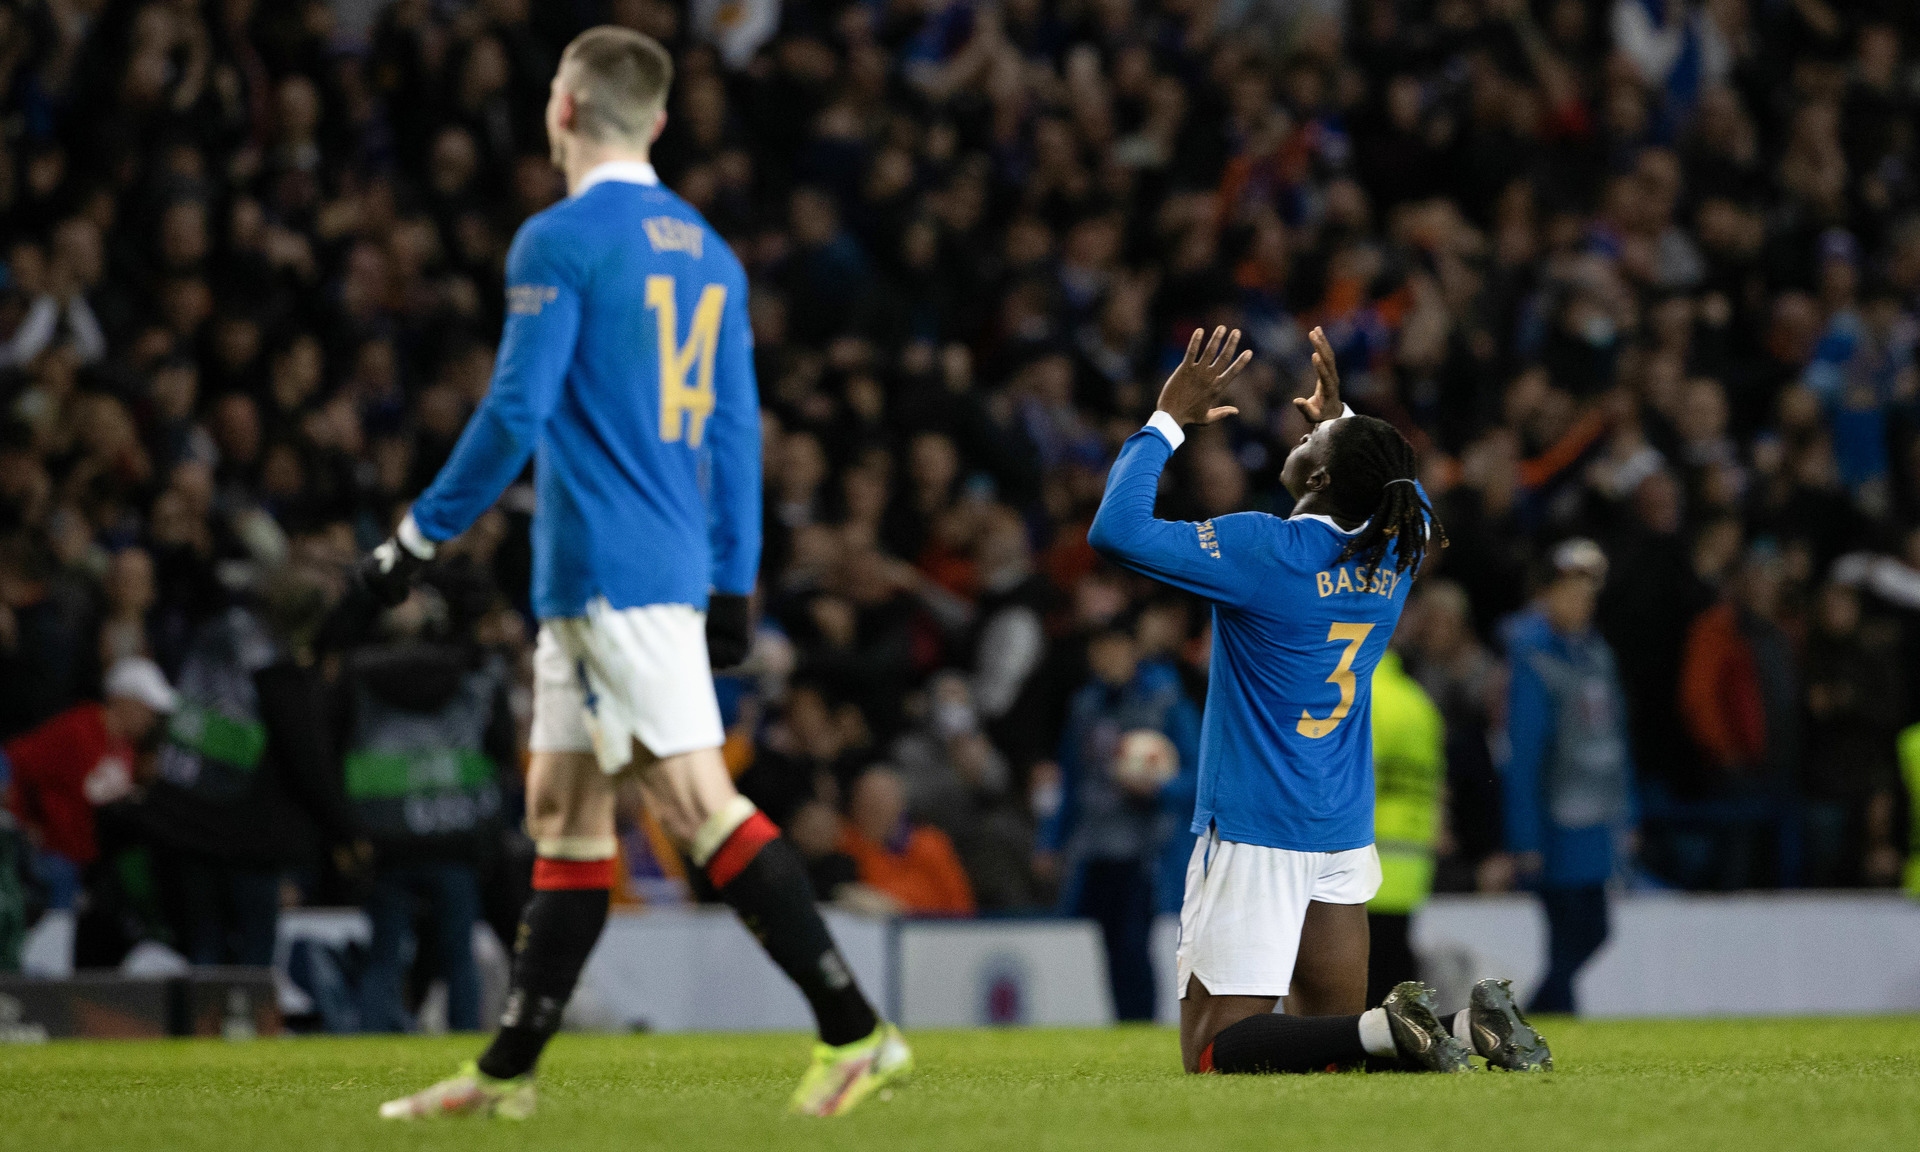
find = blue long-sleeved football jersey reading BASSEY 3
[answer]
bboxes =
[1087,418,1413,852]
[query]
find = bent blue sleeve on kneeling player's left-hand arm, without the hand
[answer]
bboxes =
[1087,428,1258,605]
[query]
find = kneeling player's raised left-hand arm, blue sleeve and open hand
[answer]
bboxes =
[1087,328,1254,603]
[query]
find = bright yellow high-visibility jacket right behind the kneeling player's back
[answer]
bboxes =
[1367,651,1446,914]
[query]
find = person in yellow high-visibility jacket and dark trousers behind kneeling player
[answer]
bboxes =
[1367,637,1446,1004]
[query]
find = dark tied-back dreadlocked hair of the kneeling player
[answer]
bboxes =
[1327,417,1446,576]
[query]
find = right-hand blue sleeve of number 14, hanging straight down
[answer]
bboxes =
[707,266,760,595]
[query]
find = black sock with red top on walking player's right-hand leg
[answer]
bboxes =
[703,812,879,1044]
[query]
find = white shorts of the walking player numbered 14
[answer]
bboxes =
[528,597,726,774]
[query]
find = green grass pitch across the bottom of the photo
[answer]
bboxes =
[0,1018,1920,1152]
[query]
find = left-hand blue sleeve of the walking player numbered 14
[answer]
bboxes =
[413,217,580,541]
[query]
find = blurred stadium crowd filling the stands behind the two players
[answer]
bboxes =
[0,0,1920,1025]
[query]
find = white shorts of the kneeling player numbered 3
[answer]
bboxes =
[1175,829,1380,998]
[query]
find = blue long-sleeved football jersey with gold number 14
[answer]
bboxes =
[413,163,760,620]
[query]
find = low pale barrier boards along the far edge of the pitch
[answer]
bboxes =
[15,893,1920,1031]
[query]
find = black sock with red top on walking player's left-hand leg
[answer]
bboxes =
[480,860,612,1079]
